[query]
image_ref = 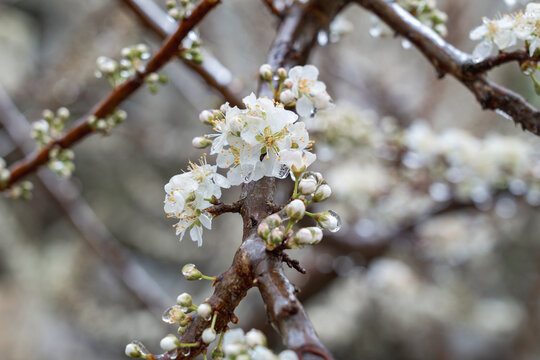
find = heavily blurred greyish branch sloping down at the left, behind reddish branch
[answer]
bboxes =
[0,86,168,315]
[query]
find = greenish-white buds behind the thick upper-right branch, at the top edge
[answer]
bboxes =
[369,0,448,40]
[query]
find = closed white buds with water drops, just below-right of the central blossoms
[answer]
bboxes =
[257,171,341,251]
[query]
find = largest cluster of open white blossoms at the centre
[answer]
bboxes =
[210,94,310,185]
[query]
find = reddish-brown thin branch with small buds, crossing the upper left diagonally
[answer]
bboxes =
[0,0,220,190]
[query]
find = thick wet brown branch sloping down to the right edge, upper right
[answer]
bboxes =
[355,0,540,136]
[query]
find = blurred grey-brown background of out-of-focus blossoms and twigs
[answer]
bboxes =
[0,0,540,360]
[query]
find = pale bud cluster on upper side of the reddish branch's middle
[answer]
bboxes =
[95,44,167,93]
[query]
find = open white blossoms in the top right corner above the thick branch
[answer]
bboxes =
[470,3,540,61]
